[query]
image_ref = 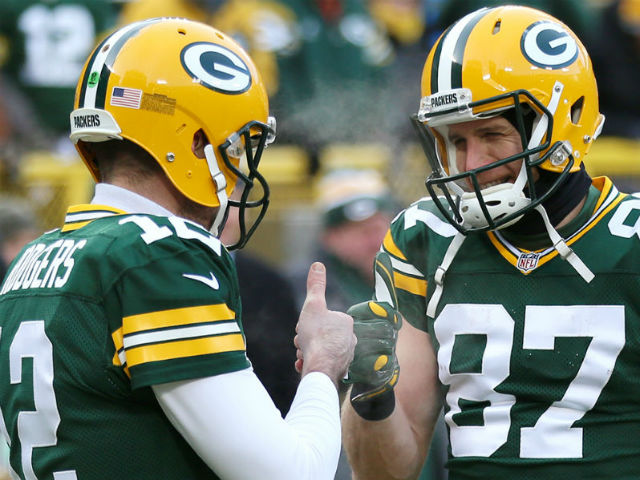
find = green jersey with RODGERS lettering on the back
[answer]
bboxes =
[0,205,250,480]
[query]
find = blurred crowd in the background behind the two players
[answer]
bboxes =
[0,0,640,479]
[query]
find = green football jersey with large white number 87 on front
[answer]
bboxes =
[384,178,640,480]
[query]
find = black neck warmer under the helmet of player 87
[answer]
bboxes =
[506,164,591,235]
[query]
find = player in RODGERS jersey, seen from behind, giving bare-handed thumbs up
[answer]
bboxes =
[0,19,355,480]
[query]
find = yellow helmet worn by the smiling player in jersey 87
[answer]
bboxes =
[413,6,604,233]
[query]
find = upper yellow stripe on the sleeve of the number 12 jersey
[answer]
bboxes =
[122,303,236,335]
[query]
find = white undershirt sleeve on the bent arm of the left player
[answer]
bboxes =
[153,369,340,480]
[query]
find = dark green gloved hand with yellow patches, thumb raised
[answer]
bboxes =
[345,252,402,406]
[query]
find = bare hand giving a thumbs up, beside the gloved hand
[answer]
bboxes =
[293,262,356,386]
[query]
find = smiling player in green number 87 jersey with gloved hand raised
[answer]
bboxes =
[343,6,640,480]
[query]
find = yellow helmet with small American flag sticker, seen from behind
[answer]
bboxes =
[70,18,275,248]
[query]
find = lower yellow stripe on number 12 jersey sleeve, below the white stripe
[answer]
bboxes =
[127,333,245,367]
